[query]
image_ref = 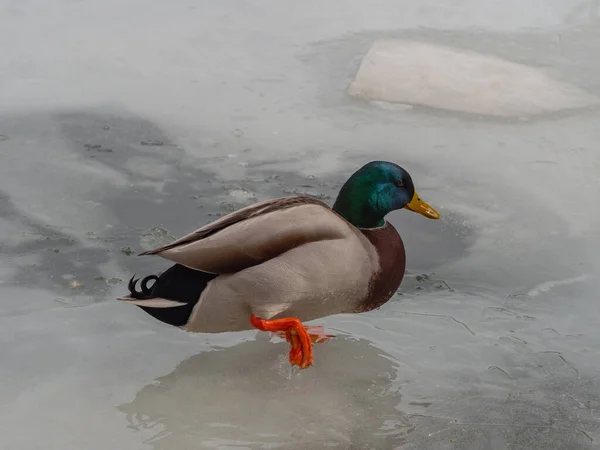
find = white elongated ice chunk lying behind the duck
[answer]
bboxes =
[348,39,597,117]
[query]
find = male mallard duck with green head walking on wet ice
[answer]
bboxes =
[119,161,440,368]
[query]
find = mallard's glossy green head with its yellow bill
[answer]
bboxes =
[333,161,440,228]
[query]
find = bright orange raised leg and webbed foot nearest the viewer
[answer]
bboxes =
[250,314,314,369]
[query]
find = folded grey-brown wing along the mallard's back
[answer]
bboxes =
[140,196,352,274]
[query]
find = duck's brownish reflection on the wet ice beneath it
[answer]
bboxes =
[119,334,411,450]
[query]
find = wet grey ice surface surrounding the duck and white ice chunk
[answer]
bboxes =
[0,0,600,450]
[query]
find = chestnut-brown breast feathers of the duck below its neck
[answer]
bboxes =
[355,222,406,313]
